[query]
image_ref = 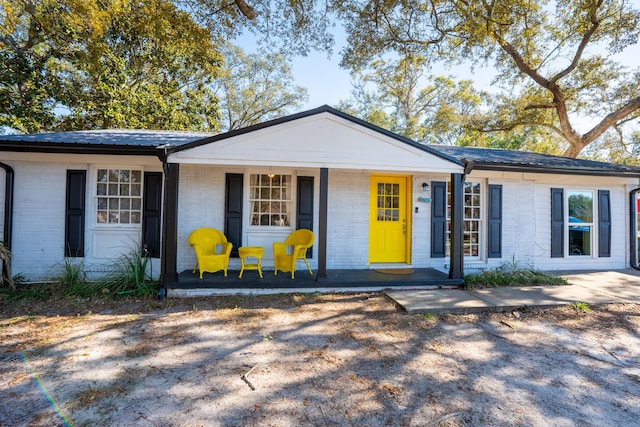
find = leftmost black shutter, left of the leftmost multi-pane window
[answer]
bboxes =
[64,170,87,257]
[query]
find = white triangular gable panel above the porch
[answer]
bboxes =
[167,112,463,173]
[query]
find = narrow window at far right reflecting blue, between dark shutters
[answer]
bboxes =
[566,191,594,256]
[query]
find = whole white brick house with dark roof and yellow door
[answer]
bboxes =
[0,106,640,287]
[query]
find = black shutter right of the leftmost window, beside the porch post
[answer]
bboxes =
[142,172,163,258]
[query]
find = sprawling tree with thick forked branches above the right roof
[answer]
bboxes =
[336,0,640,157]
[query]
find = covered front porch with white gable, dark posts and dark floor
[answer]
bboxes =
[158,107,464,290]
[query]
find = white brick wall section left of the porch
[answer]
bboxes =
[5,154,160,281]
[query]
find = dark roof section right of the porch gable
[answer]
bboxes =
[430,145,640,177]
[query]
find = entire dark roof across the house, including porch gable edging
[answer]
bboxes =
[0,109,640,177]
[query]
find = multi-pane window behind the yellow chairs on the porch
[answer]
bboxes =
[249,174,292,227]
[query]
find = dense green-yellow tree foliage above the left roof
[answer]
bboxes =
[0,0,222,132]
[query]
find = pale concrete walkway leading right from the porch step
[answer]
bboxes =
[386,269,640,314]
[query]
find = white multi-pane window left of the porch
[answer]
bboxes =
[96,169,142,224]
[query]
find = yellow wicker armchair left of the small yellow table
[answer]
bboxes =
[189,227,233,279]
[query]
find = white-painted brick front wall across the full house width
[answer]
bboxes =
[5,156,629,280]
